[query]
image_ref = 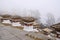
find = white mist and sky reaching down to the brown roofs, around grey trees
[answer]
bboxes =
[0,0,60,23]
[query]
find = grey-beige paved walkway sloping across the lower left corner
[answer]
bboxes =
[0,23,33,40]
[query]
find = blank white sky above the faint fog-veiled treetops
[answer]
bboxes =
[0,0,60,23]
